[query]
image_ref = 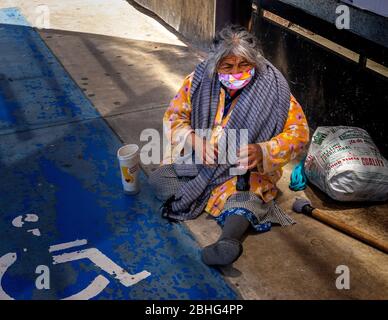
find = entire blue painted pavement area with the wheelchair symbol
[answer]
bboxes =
[0,8,237,299]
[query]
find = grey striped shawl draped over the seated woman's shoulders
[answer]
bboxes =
[170,61,290,220]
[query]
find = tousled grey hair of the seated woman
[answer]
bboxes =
[207,25,265,77]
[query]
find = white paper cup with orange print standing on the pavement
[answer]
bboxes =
[117,144,140,194]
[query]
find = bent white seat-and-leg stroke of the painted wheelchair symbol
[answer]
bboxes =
[53,248,151,287]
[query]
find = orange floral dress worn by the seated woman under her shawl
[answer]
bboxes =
[162,73,309,217]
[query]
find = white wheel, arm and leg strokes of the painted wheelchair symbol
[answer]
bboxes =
[0,239,151,300]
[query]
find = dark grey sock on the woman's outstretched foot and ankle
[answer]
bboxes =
[202,215,250,266]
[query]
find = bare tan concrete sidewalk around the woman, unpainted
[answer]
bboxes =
[1,0,388,299]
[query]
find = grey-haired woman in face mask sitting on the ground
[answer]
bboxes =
[150,26,309,266]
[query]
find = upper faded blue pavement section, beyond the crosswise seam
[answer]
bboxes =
[0,9,99,133]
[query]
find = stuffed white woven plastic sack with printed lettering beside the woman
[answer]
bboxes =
[304,126,388,201]
